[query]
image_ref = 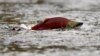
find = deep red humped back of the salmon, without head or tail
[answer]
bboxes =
[31,17,69,30]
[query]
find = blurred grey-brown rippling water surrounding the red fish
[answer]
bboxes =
[0,0,100,56]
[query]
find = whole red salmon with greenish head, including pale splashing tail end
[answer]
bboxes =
[12,17,83,31]
